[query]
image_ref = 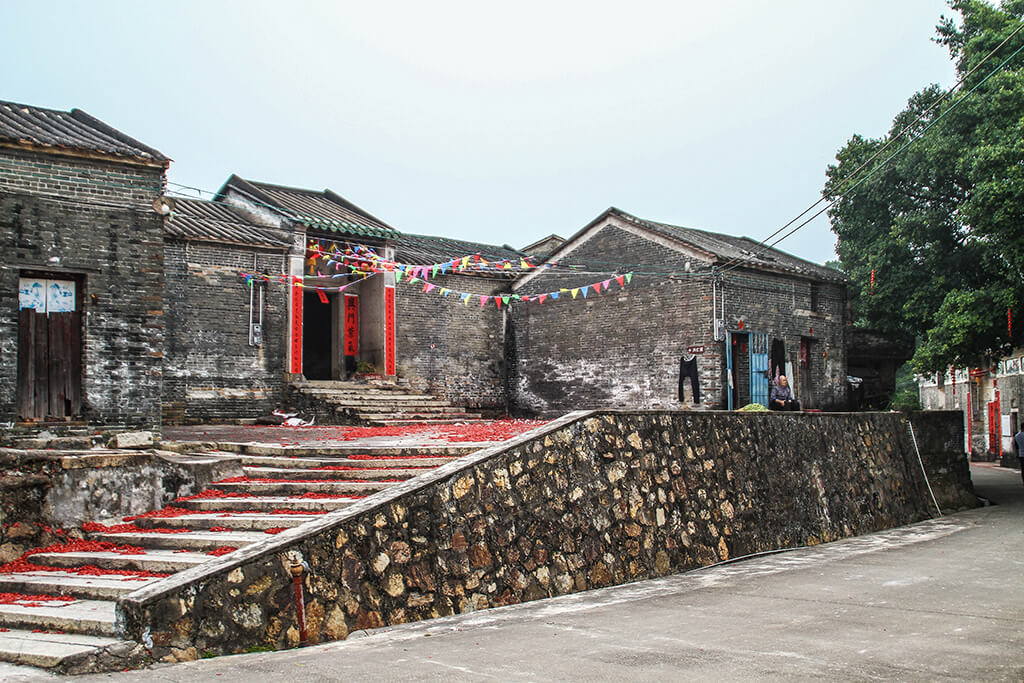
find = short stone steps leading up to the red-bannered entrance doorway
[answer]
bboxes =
[286,380,483,426]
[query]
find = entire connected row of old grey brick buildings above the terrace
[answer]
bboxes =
[0,103,847,425]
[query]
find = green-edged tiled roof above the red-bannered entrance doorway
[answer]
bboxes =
[221,175,398,240]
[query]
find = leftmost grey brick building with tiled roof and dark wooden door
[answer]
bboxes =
[0,102,169,425]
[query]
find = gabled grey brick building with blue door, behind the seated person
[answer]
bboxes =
[508,209,847,414]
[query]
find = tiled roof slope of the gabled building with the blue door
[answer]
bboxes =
[610,208,846,282]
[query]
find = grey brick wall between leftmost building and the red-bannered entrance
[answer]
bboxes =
[163,240,288,424]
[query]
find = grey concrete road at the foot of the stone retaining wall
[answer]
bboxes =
[0,465,1024,682]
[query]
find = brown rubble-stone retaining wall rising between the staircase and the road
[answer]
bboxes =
[119,412,966,660]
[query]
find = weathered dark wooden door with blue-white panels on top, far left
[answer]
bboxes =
[17,278,82,420]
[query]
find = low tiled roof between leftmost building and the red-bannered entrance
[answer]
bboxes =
[164,199,289,249]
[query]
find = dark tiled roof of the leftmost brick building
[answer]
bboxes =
[0,101,170,162]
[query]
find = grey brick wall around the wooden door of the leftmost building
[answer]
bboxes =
[0,148,164,426]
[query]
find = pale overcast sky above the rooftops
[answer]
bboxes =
[0,0,953,262]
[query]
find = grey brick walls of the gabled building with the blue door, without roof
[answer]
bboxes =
[508,225,846,414]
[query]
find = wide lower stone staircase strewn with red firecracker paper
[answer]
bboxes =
[0,444,479,674]
